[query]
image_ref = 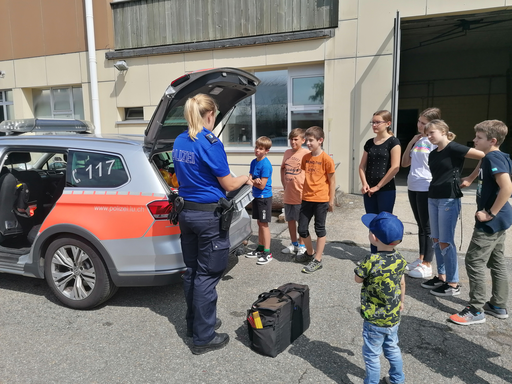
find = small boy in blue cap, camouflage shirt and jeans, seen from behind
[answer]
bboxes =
[354,212,407,384]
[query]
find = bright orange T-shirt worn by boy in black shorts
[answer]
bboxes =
[301,151,335,203]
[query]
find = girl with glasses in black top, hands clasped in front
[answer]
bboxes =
[359,110,400,253]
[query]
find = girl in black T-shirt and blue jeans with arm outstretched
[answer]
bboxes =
[421,120,484,296]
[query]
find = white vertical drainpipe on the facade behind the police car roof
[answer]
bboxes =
[85,0,101,134]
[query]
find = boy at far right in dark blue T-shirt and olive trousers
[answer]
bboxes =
[450,120,512,325]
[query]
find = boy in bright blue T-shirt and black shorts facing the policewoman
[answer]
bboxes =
[245,136,272,265]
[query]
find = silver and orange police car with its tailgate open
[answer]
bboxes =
[0,68,259,309]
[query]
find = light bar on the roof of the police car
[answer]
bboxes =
[0,119,94,135]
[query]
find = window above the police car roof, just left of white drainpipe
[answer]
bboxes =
[32,87,84,120]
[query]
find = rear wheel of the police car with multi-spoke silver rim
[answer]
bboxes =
[44,237,117,309]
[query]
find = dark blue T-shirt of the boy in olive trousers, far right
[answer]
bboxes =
[475,151,512,233]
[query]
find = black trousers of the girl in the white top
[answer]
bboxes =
[408,191,434,263]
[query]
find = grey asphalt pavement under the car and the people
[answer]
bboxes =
[0,182,512,384]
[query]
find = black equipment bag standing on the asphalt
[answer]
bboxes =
[247,283,310,357]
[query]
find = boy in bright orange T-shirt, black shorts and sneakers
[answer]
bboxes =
[295,126,336,273]
